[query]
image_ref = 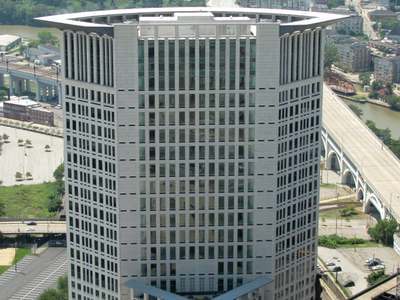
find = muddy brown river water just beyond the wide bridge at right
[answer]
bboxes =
[342,99,400,139]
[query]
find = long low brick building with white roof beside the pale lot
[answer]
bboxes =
[4,97,54,126]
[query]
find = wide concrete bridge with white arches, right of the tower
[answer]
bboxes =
[321,84,400,223]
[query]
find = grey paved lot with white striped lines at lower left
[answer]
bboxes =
[0,248,68,300]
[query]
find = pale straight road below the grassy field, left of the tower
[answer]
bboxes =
[0,221,66,234]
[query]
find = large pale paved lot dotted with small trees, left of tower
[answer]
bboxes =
[0,126,64,186]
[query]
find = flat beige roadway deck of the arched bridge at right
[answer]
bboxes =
[323,84,400,221]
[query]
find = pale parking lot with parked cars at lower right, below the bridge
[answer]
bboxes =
[318,247,399,295]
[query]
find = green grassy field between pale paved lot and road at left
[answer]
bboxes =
[0,182,60,218]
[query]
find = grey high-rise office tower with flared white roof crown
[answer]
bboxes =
[40,8,341,300]
